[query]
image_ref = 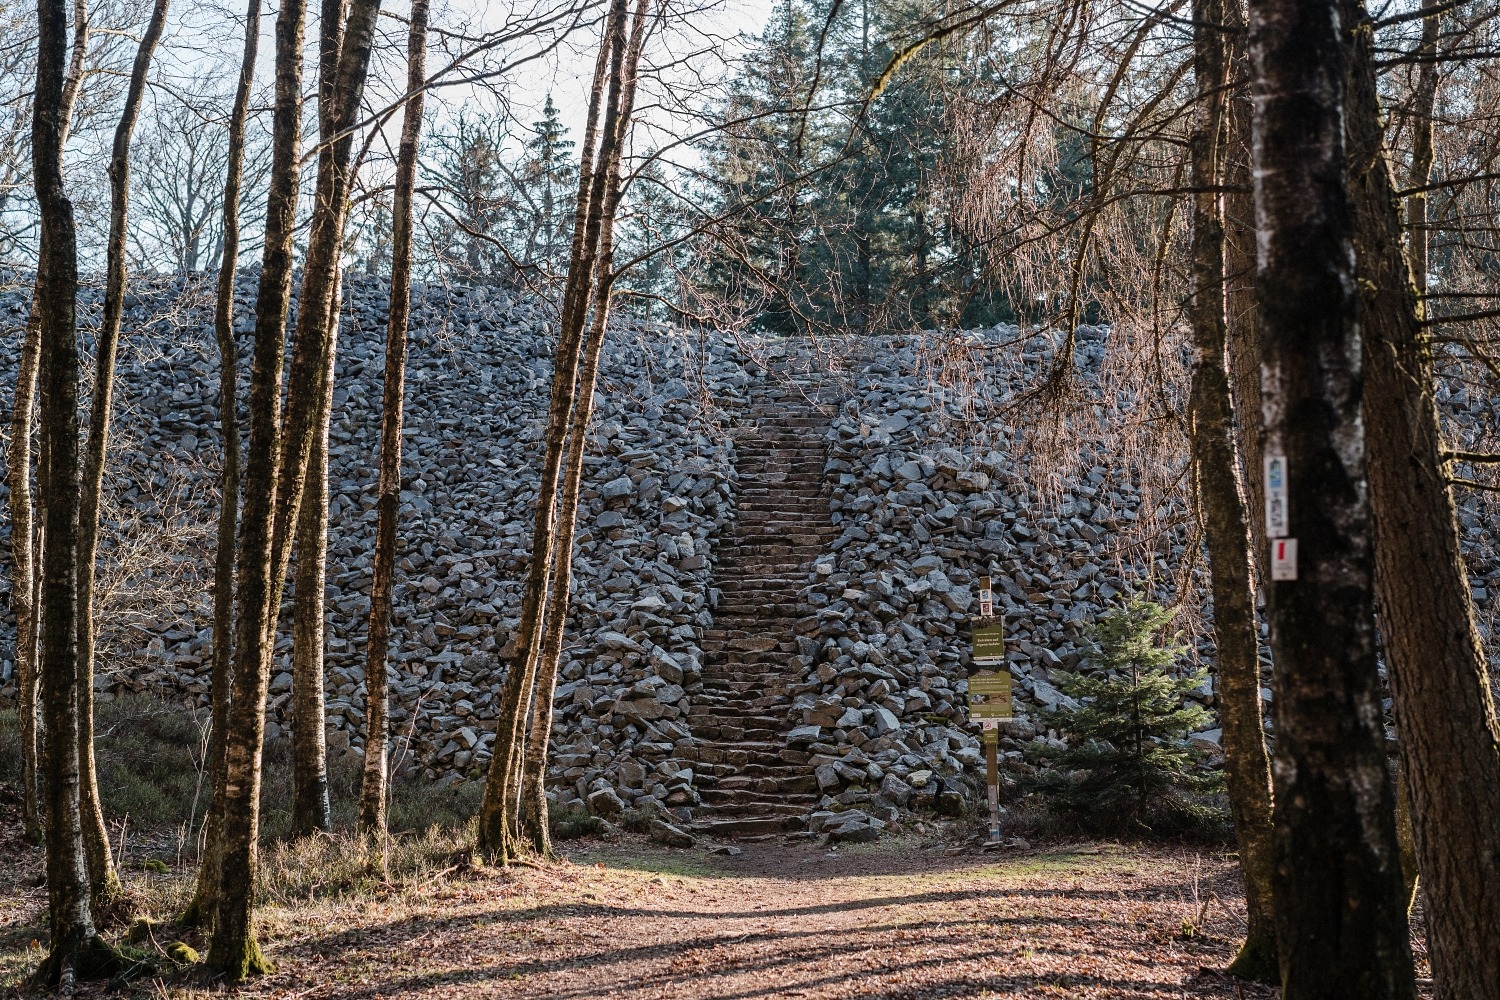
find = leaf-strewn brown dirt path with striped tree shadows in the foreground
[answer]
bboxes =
[217,843,1271,1000]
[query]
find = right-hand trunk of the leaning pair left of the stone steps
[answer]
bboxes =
[521,0,650,856]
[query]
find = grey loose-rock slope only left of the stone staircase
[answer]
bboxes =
[0,274,746,790]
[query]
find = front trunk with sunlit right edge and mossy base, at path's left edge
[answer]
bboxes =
[209,0,306,982]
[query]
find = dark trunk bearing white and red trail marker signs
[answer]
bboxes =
[1250,0,1416,1000]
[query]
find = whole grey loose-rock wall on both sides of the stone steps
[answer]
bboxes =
[0,274,1500,817]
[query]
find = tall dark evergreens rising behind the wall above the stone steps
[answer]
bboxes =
[704,0,1013,333]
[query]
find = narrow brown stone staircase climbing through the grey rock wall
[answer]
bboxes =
[692,374,839,838]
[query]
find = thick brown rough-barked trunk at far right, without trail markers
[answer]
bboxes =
[1343,0,1500,1000]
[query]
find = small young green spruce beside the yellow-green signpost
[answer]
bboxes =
[1038,600,1223,834]
